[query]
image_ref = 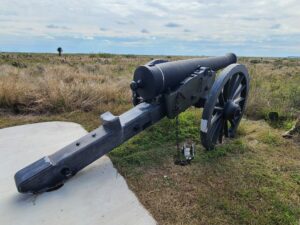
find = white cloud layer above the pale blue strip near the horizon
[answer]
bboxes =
[0,0,300,54]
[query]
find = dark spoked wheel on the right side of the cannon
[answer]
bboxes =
[201,64,249,150]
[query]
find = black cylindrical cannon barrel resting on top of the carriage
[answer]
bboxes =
[131,53,237,101]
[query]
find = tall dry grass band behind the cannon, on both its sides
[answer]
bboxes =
[0,54,300,124]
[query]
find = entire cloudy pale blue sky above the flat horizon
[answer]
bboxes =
[0,0,300,57]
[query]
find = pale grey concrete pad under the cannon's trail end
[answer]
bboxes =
[0,122,156,225]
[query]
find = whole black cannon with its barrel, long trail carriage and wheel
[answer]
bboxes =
[15,54,249,193]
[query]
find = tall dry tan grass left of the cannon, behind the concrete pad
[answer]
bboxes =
[0,53,151,114]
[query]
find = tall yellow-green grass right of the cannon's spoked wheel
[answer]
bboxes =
[240,58,300,119]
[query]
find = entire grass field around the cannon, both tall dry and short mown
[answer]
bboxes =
[0,53,300,225]
